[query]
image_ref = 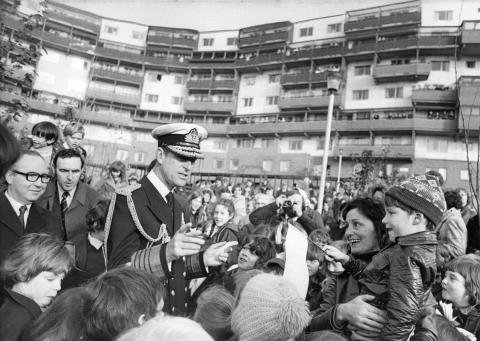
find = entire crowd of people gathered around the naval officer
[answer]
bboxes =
[0,117,480,341]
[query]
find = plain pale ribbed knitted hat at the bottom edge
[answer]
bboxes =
[232,274,310,341]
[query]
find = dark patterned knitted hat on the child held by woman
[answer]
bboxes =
[385,175,447,225]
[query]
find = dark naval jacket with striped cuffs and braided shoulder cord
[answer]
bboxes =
[107,177,208,315]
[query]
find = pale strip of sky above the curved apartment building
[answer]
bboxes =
[56,0,398,31]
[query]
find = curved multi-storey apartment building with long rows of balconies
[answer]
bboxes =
[0,0,480,187]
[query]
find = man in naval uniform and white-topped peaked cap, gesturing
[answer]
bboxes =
[105,123,231,316]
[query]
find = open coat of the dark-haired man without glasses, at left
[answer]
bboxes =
[37,181,101,240]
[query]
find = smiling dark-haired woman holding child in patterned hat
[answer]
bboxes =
[311,198,388,334]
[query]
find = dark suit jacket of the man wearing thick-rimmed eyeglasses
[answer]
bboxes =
[0,193,62,263]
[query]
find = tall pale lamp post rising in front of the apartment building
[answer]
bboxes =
[317,71,342,213]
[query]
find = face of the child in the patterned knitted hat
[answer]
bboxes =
[382,206,420,242]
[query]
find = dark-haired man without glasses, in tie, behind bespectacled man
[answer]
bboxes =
[38,149,101,240]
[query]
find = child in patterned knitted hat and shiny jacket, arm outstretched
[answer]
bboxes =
[325,175,446,341]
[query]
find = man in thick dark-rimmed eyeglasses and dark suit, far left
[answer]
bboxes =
[0,151,61,263]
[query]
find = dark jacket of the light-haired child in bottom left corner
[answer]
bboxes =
[0,289,42,341]
